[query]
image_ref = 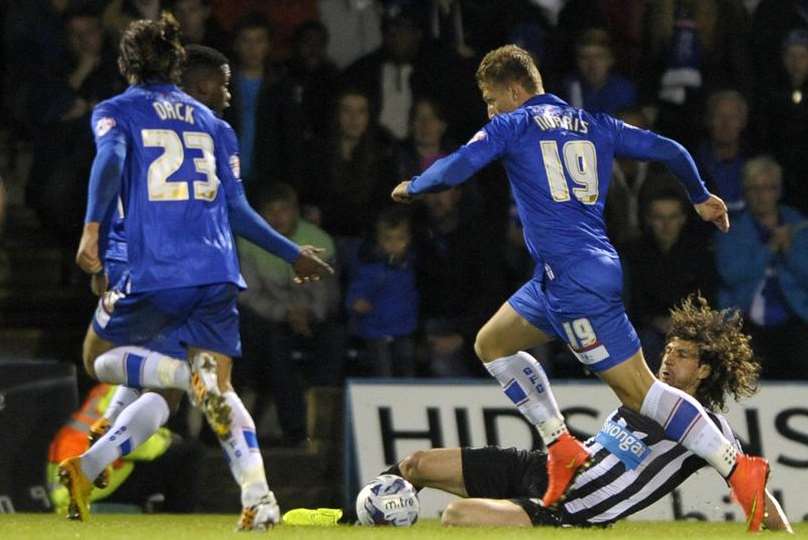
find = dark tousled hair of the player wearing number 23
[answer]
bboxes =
[118,11,185,84]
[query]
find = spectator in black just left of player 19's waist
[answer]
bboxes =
[416,187,505,377]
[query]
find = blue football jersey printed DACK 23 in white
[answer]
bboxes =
[92,85,245,292]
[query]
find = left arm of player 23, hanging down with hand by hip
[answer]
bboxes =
[76,107,127,274]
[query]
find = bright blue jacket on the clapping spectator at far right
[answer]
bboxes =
[716,205,808,321]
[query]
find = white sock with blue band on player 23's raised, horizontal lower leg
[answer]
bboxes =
[93,346,191,390]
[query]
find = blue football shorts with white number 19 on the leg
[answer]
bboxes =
[508,255,640,373]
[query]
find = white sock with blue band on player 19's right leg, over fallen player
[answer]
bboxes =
[640,381,738,478]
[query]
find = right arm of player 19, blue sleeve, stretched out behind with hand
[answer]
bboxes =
[611,119,729,232]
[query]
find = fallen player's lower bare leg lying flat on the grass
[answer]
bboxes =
[441,499,533,527]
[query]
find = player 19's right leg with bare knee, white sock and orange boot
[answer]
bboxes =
[598,350,769,531]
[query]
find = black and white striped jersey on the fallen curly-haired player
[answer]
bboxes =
[562,407,740,524]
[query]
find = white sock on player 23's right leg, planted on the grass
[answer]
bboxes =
[219,391,270,507]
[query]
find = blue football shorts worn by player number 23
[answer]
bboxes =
[92,265,241,358]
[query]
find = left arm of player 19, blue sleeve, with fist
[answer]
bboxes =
[391,115,512,202]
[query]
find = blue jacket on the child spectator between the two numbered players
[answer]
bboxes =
[345,248,418,339]
